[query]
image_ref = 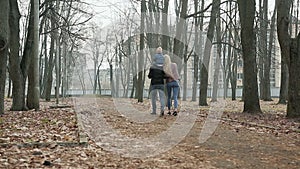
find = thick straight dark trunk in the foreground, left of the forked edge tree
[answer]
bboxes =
[238,0,261,113]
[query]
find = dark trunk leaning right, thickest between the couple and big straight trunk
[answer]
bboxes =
[199,0,220,106]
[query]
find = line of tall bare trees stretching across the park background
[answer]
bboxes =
[0,0,300,117]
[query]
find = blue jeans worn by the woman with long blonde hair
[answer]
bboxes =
[167,80,179,110]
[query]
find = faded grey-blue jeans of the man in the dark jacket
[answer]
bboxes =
[150,84,165,113]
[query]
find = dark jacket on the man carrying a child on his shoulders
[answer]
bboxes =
[148,65,166,85]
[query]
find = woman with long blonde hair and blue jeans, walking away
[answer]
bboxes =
[164,55,179,116]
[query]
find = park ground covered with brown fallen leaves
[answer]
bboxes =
[0,98,300,169]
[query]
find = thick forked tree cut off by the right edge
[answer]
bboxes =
[277,0,300,118]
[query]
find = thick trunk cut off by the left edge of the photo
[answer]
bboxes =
[0,0,9,114]
